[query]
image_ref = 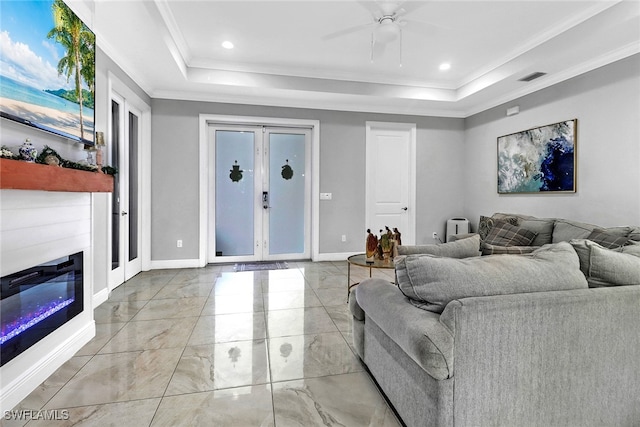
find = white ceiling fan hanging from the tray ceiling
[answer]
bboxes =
[322,1,433,66]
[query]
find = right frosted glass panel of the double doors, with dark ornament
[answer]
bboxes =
[269,133,306,255]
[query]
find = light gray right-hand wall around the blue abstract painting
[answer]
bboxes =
[464,55,640,231]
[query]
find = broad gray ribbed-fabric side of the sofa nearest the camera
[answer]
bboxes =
[441,285,640,425]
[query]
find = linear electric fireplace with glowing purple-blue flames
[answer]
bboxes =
[0,252,83,366]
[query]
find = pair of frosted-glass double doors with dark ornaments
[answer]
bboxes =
[207,125,311,262]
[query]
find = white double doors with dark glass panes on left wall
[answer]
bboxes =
[108,93,142,289]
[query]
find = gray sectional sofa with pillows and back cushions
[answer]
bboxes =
[349,214,640,426]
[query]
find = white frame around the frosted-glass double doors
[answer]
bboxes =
[198,114,320,267]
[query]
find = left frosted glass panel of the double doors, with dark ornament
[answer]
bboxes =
[215,130,255,256]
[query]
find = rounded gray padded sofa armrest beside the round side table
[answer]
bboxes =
[355,279,453,380]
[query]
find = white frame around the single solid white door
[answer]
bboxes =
[365,121,416,245]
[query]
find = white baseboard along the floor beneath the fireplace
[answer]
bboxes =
[0,320,96,414]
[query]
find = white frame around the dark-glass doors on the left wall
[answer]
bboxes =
[105,71,151,291]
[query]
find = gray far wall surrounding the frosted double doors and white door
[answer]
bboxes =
[151,99,464,261]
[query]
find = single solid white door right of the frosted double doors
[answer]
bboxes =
[365,122,416,245]
